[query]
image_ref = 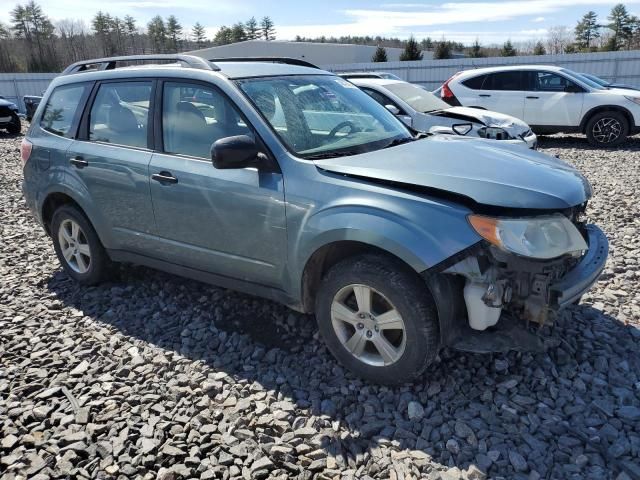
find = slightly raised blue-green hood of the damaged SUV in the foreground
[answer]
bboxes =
[315,135,591,210]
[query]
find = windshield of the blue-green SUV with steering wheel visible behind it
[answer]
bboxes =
[238,75,413,159]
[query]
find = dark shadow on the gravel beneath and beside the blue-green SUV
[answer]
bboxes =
[44,266,640,478]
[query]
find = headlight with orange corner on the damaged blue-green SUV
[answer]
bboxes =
[468,214,588,260]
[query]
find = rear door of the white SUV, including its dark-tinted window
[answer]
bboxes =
[463,70,525,118]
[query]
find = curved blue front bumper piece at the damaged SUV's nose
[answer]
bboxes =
[549,225,609,308]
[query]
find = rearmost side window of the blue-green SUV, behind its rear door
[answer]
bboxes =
[40,84,88,138]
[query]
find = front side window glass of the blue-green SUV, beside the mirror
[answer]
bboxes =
[162,82,252,159]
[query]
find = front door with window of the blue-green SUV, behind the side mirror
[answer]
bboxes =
[150,81,286,286]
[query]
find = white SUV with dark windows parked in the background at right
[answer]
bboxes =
[440,65,640,147]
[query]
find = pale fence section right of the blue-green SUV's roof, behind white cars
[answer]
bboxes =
[323,50,640,90]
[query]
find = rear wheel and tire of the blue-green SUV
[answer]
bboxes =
[51,205,111,285]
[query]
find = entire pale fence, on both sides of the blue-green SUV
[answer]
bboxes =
[6,50,640,112]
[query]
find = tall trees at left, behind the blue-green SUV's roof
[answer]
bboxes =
[0,0,275,72]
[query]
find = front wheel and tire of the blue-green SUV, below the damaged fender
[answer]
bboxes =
[316,254,440,385]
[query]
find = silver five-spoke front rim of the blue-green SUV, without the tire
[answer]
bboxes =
[331,284,407,366]
